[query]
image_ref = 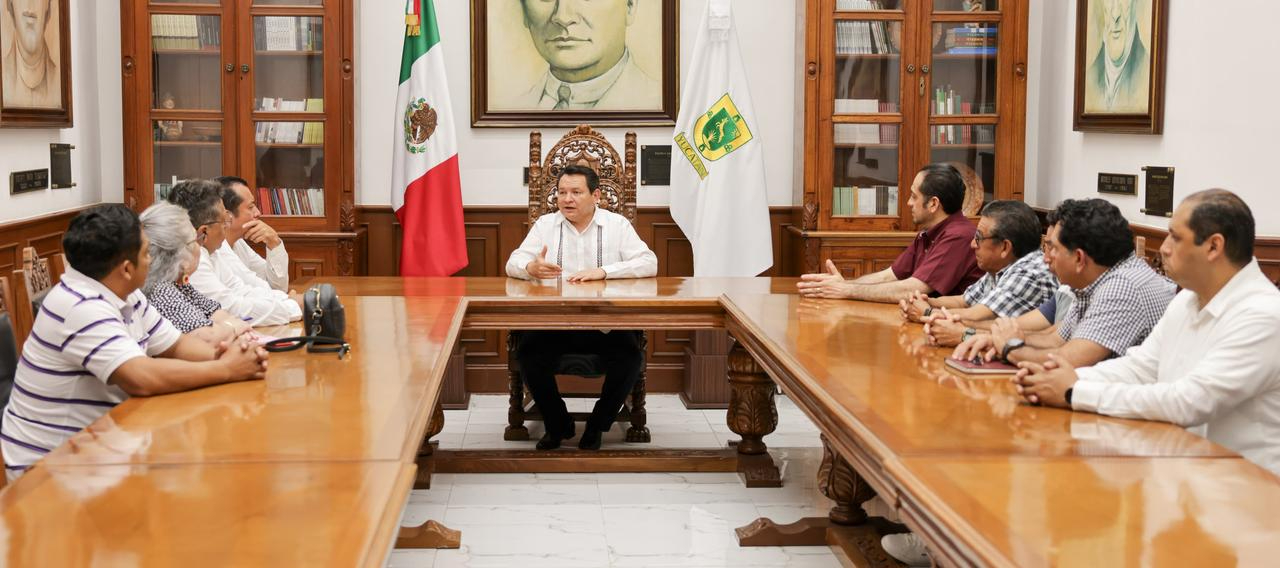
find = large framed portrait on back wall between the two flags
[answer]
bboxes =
[471,0,680,127]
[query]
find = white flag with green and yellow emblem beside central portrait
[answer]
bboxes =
[671,0,773,276]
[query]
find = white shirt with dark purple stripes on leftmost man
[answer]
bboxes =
[0,267,180,473]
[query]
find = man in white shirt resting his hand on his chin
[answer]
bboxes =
[216,175,289,292]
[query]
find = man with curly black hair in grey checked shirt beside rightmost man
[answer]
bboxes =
[954,198,1176,366]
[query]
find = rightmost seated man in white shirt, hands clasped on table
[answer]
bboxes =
[1014,189,1280,475]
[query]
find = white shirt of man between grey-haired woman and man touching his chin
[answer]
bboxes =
[191,243,302,326]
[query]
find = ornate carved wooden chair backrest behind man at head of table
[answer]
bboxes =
[529,124,636,225]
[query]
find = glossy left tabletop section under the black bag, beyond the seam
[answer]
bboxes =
[44,292,461,464]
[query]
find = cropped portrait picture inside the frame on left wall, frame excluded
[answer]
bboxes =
[0,0,64,109]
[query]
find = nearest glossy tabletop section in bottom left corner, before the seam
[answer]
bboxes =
[0,462,415,568]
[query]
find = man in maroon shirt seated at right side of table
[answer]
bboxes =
[796,164,982,303]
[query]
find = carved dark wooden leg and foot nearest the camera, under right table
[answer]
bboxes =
[735,436,901,567]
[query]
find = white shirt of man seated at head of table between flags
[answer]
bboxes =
[507,207,658,280]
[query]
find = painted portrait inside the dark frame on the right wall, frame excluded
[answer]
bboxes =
[1084,0,1152,114]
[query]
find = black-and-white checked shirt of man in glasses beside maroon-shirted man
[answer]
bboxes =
[964,251,1057,317]
